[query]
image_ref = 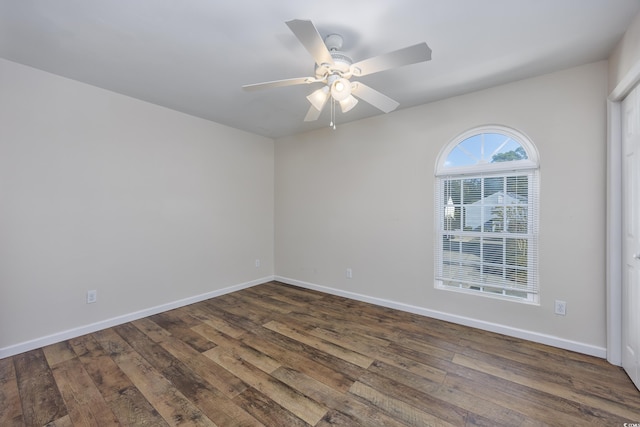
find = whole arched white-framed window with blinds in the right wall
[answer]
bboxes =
[435,126,539,303]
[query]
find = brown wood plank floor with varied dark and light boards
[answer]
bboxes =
[0,282,640,427]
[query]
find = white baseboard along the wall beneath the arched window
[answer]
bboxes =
[274,276,607,359]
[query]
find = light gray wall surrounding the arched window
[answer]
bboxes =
[275,61,607,357]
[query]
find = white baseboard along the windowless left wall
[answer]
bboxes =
[0,276,274,359]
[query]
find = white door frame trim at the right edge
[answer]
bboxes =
[606,61,640,366]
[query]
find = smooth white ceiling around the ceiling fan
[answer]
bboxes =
[0,0,640,138]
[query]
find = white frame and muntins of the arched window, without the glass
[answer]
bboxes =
[434,125,540,305]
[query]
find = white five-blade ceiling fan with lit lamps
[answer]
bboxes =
[242,19,431,128]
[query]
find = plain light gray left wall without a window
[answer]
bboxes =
[0,60,274,357]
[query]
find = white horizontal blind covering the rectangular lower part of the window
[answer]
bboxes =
[435,169,539,301]
